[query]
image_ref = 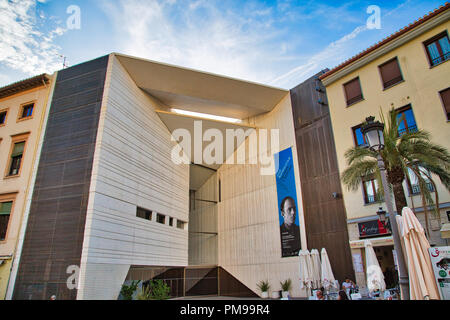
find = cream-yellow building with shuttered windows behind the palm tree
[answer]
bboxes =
[320,4,450,286]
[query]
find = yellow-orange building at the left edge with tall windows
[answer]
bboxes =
[0,74,52,300]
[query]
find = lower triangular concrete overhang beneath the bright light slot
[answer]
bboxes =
[156,110,256,190]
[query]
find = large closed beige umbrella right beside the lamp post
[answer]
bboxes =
[400,207,440,300]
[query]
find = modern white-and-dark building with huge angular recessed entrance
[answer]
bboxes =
[0,53,352,299]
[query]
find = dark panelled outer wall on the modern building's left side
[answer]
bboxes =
[13,56,108,300]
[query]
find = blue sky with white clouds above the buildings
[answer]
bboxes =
[0,0,445,89]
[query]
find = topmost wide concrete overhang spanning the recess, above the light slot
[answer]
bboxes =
[114,53,289,119]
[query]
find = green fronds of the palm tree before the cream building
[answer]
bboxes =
[341,108,450,235]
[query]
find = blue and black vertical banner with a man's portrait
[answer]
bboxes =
[275,148,301,258]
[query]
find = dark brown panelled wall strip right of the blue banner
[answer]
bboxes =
[291,73,354,282]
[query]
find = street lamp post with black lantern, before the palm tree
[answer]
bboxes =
[361,117,409,300]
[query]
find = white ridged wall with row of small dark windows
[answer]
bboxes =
[77,55,189,299]
